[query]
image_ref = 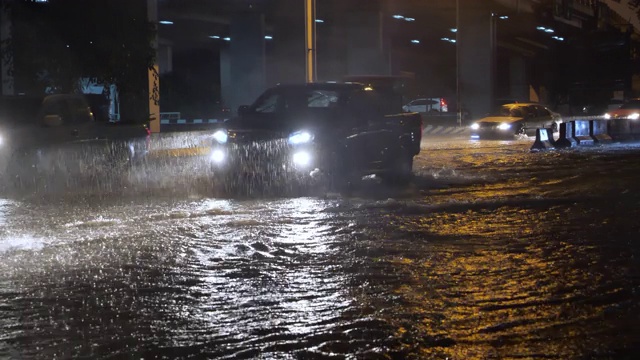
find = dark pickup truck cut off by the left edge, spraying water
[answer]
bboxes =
[0,94,150,187]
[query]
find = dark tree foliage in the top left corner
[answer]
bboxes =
[3,0,156,119]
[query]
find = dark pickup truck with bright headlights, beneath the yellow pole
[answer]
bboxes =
[210,83,422,188]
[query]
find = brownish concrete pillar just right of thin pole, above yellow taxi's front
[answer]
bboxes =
[457,0,496,118]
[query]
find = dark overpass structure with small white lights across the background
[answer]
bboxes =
[149,0,640,131]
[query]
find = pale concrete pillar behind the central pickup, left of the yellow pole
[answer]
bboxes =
[223,12,266,111]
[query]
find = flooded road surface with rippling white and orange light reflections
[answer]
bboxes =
[0,139,640,359]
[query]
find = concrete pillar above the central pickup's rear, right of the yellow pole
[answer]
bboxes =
[342,0,389,75]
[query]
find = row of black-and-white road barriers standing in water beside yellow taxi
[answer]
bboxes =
[531,116,640,151]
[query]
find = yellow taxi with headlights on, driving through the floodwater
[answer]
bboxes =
[471,103,562,139]
